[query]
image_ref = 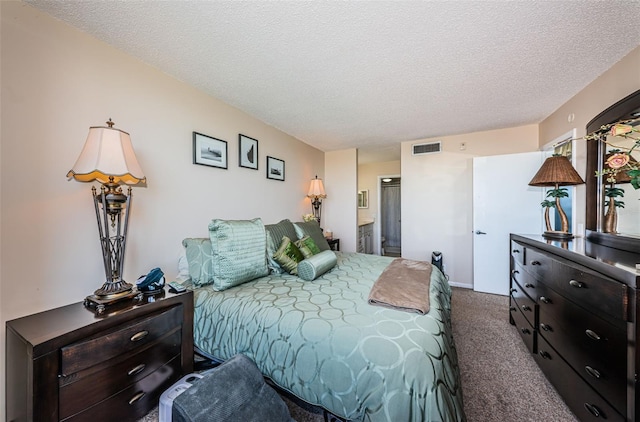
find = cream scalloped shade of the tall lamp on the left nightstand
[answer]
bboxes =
[67,126,146,185]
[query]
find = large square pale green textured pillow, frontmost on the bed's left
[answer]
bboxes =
[209,218,269,290]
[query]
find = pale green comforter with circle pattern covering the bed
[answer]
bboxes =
[194,252,465,422]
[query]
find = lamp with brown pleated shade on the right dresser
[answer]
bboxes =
[529,155,584,239]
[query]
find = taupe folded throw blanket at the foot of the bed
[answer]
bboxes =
[369,258,432,315]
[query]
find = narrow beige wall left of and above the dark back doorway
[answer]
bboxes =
[358,160,400,254]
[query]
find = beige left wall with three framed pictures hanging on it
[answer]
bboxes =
[0,2,324,414]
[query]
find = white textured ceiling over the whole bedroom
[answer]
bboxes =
[27,0,640,162]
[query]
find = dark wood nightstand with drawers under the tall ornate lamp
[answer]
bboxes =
[6,291,193,422]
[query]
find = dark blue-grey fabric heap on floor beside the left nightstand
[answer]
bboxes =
[172,355,295,422]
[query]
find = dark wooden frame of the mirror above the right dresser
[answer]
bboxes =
[585,90,640,253]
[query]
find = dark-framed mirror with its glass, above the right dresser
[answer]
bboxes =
[586,90,640,253]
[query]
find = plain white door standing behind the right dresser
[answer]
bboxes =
[473,152,544,295]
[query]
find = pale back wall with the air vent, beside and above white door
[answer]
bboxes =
[401,125,538,287]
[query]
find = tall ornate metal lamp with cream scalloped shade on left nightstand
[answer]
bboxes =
[67,119,147,314]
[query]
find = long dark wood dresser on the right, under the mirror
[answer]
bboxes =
[509,234,640,421]
